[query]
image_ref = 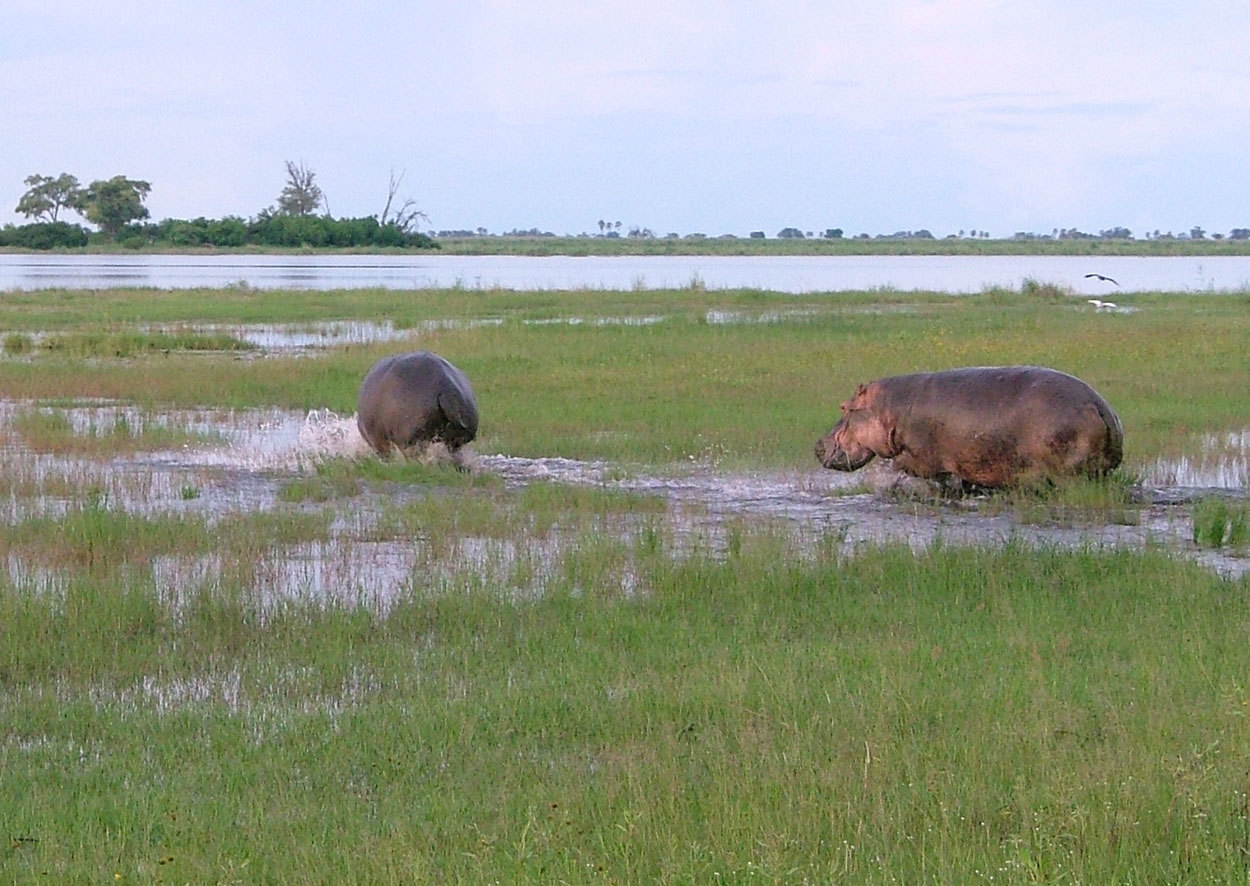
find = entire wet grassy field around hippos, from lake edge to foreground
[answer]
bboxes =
[0,283,1250,884]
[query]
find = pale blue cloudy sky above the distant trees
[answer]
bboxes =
[0,0,1250,236]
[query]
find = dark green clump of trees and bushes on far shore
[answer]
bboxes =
[0,160,438,250]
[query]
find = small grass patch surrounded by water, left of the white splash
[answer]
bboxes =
[11,409,221,457]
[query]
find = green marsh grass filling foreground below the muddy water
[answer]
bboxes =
[0,529,1250,882]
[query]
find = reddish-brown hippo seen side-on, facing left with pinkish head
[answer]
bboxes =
[816,366,1124,487]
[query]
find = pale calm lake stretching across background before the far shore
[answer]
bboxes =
[0,254,1250,297]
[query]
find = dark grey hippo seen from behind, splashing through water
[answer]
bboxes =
[356,351,478,465]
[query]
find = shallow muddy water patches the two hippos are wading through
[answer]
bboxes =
[0,401,1250,609]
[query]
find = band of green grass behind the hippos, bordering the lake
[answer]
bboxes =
[0,290,1250,470]
